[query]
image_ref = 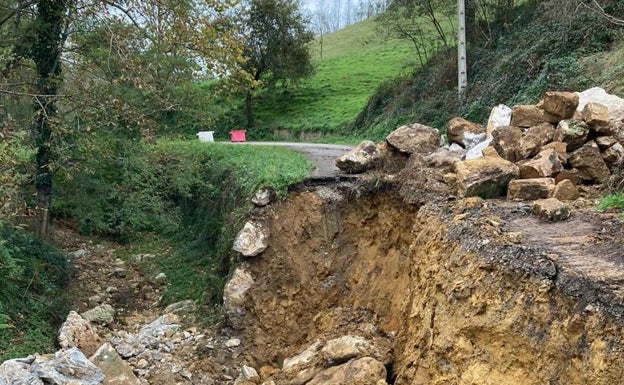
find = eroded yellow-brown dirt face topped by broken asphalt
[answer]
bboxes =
[229,184,624,385]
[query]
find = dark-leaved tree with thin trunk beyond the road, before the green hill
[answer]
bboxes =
[241,0,314,128]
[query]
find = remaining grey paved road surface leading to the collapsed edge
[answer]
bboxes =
[222,142,353,178]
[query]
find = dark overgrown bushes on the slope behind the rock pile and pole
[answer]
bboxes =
[352,0,624,137]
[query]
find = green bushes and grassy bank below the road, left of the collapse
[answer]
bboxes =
[54,138,311,320]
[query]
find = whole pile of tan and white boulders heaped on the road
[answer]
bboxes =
[336,88,624,220]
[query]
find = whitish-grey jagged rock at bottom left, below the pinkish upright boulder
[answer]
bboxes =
[31,348,104,385]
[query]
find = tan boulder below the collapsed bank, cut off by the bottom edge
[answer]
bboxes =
[307,357,387,385]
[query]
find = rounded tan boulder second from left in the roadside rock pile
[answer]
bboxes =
[386,123,440,154]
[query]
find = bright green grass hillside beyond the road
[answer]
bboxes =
[229,20,415,136]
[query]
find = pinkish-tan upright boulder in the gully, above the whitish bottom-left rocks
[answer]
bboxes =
[58,311,102,355]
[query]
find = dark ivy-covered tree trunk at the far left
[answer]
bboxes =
[32,0,67,237]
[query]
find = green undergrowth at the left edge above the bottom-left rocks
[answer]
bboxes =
[0,225,70,362]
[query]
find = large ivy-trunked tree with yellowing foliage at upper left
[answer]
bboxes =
[0,0,249,235]
